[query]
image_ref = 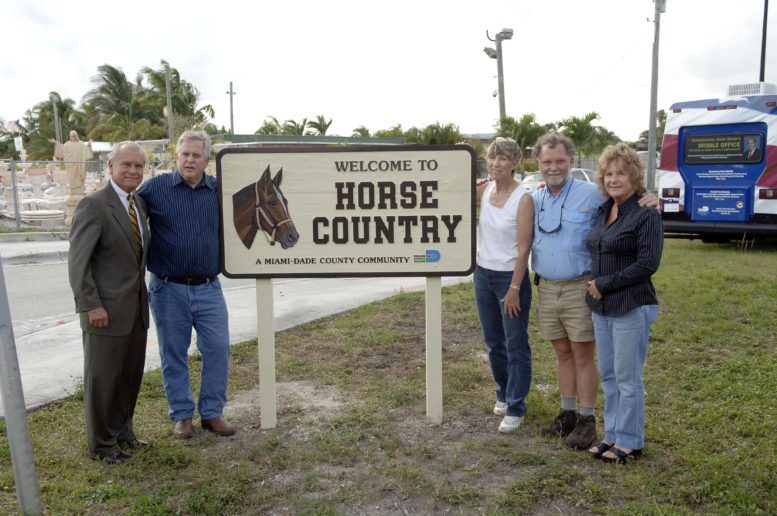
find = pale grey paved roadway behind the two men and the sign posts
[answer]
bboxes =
[0,236,470,415]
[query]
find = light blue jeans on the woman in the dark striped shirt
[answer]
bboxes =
[592,305,658,450]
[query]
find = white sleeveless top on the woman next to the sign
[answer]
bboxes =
[477,181,525,272]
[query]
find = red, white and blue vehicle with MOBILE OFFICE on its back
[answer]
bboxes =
[657,83,777,241]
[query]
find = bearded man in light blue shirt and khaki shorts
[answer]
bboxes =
[531,133,657,450]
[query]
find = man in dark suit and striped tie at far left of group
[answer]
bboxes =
[68,142,149,464]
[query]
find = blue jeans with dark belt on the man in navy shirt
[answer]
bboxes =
[148,275,229,421]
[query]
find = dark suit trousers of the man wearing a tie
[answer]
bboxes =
[83,310,148,457]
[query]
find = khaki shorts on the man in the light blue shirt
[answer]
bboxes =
[537,276,595,342]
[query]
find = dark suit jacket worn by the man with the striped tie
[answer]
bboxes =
[68,184,150,337]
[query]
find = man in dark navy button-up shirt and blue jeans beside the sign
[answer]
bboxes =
[138,131,235,439]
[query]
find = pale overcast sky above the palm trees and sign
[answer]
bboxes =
[0,0,777,140]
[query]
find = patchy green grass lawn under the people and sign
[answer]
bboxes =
[0,240,777,515]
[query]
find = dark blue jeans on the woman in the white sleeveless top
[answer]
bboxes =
[474,266,531,416]
